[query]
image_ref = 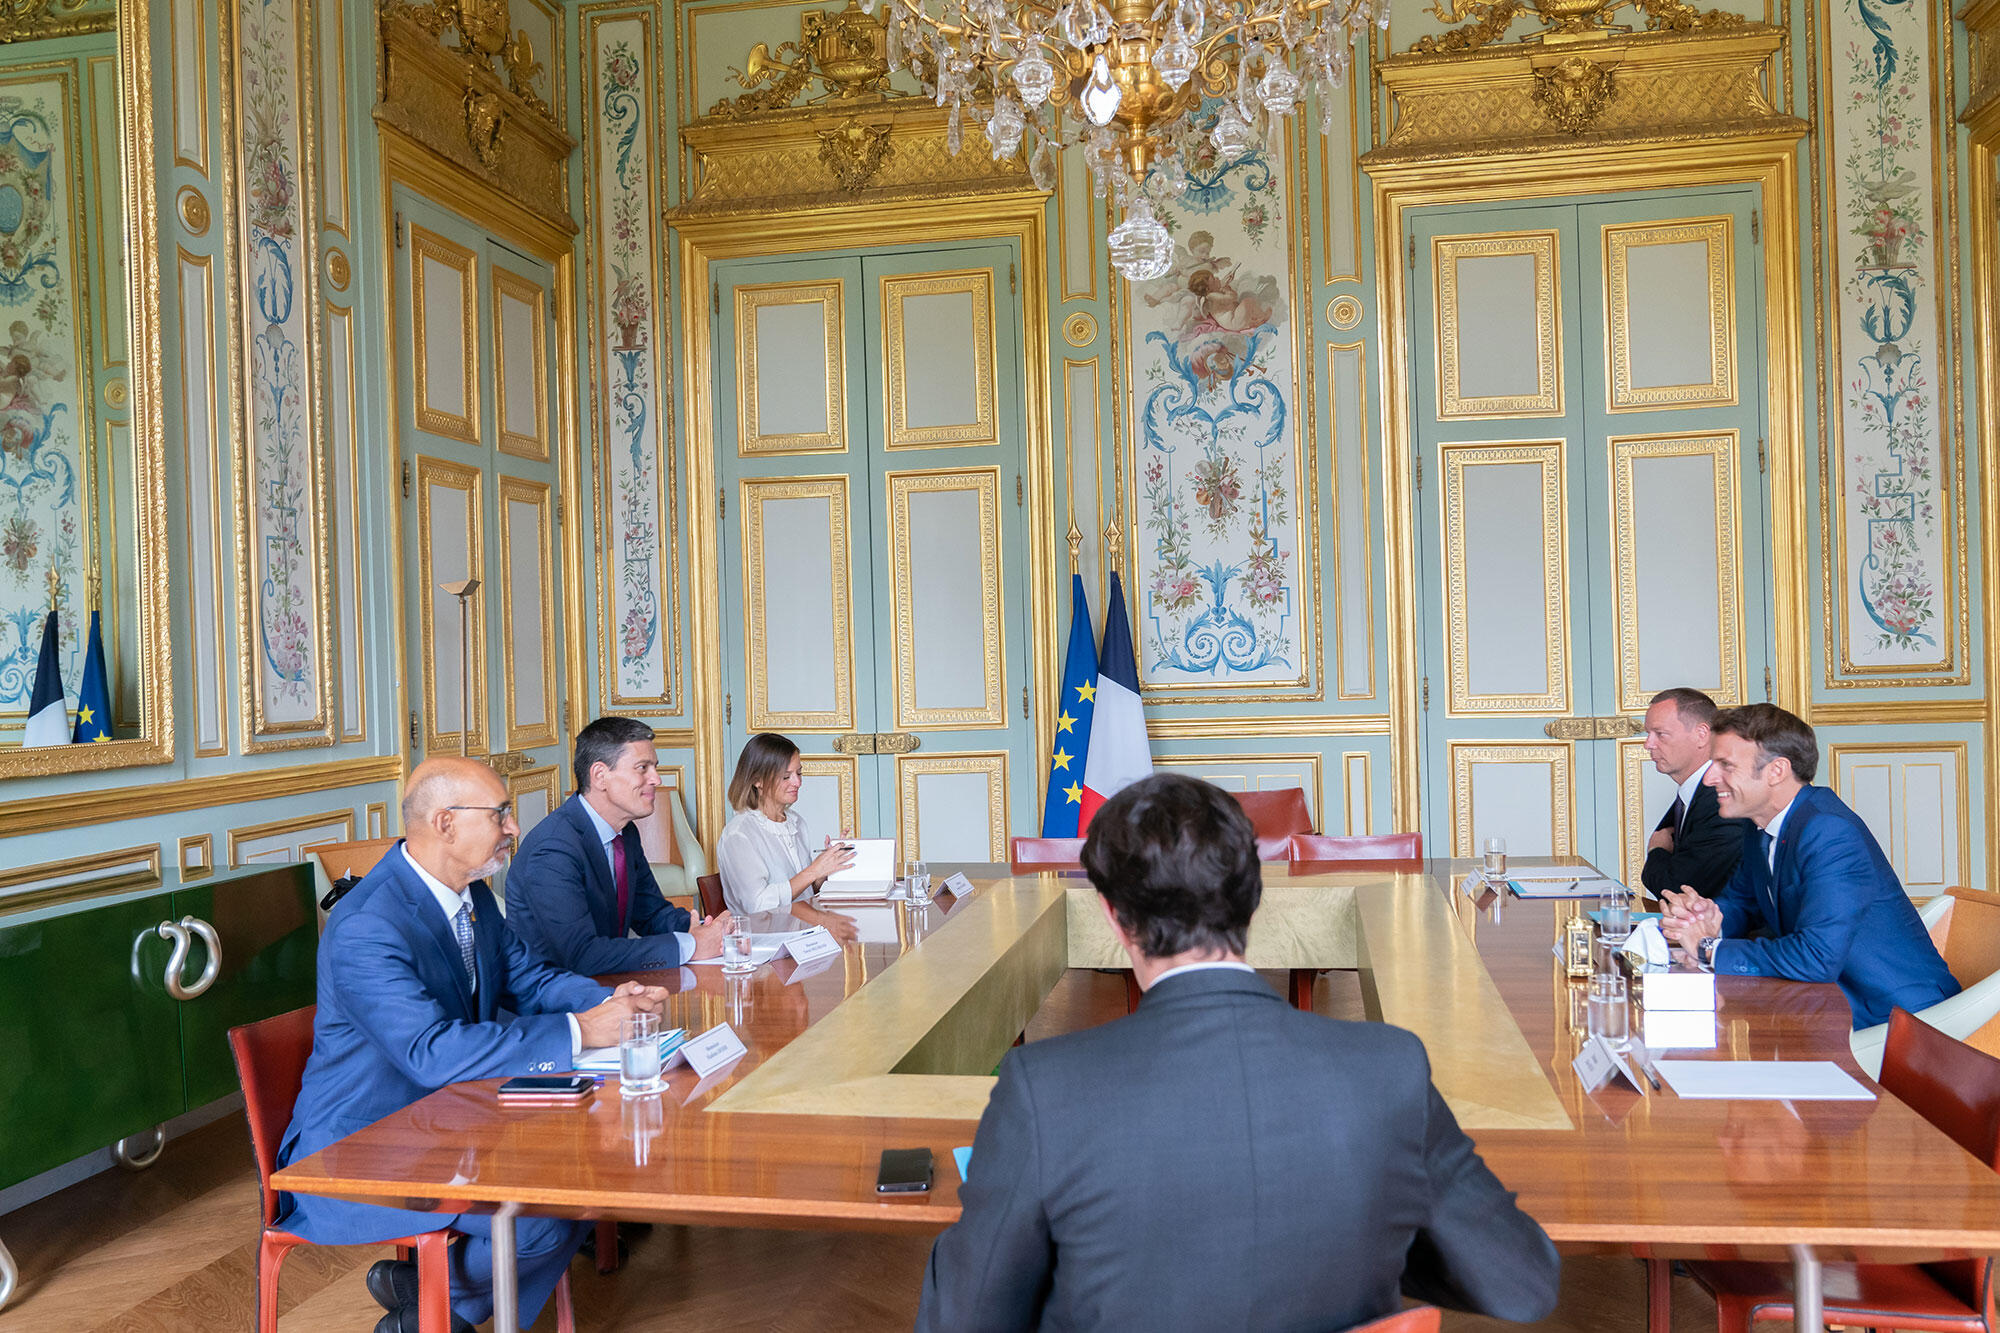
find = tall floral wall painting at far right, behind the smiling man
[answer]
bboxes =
[1828,0,1958,671]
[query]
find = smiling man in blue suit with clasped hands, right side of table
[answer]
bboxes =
[1662,705,1958,1027]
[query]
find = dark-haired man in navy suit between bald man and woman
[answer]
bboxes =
[506,717,730,964]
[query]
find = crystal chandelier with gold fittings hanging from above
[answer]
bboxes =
[862,0,1388,280]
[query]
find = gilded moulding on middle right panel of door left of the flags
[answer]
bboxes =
[888,468,1006,731]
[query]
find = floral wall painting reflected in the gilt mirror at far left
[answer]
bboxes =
[0,66,90,727]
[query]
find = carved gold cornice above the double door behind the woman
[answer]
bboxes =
[668,98,1034,222]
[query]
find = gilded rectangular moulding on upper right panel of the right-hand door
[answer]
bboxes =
[1604,216,1736,412]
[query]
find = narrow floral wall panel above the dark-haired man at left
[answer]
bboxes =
[588,12,674,713]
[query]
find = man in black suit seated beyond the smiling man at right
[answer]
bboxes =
[1640,687,1748,899]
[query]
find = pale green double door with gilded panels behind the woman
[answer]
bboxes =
[712,244,1038,861]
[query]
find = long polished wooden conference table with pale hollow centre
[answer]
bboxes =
[274,861,2000,1333]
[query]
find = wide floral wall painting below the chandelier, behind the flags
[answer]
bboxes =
[1130,102,1306,689]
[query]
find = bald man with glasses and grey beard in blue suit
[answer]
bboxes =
[278,759,666,1333]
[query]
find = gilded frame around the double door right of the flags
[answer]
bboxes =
[1366,128,1816,829]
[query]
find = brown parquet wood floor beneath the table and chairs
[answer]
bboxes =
[0,973,1752,1333]
